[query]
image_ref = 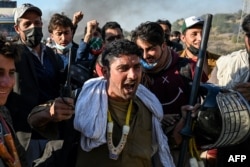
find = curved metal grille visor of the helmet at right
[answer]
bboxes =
[210,90,250,147]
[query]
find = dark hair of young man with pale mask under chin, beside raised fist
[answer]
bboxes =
[48,13,74,33]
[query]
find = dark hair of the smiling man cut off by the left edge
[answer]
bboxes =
[0,36,20,61]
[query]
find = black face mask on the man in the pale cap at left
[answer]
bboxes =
[23,27,43,48]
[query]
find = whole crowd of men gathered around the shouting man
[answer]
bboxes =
[0,3,250,167]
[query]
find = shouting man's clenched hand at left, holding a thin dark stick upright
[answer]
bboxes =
[49,97,74,122]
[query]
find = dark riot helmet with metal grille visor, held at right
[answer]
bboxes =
[195,84,250,149]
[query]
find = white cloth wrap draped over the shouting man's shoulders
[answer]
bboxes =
[74,77,175,167]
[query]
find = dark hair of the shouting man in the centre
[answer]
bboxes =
[102,39,142,68]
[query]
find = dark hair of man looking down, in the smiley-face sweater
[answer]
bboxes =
[131,22,165,45]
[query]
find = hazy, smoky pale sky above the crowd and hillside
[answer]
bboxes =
[17,0,246,34]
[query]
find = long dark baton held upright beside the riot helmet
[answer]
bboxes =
[177,14,213,167]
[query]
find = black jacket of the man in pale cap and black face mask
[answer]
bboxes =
[6,42,63,148]
